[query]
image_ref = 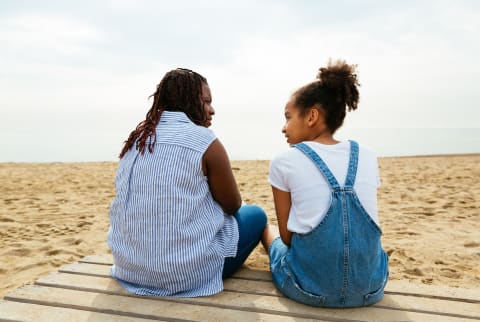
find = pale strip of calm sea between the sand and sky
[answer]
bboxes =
[0,127,480,162]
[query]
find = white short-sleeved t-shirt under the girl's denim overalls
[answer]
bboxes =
[268,141,380,234]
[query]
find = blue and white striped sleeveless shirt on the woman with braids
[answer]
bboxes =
[107,111,238,297]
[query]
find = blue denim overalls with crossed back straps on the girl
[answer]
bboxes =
[269,141,388,307]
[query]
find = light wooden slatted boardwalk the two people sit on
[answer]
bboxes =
[0,255,480,322]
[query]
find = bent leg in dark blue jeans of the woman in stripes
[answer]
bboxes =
[222,205,267,279]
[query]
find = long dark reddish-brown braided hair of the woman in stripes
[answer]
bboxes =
[119,68,207,159]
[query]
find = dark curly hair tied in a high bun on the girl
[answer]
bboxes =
[293,60,360,134]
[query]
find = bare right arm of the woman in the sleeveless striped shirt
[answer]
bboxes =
[202,139,242,215]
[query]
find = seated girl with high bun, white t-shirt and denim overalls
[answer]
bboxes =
[262,61,388,307]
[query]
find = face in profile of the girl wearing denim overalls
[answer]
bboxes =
[282,97,308,144]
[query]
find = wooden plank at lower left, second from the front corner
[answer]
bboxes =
[0,285,326,322]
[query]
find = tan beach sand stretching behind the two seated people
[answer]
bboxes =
[0,154,480,298]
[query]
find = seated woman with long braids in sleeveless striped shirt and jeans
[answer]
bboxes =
[107,69,266,297]
